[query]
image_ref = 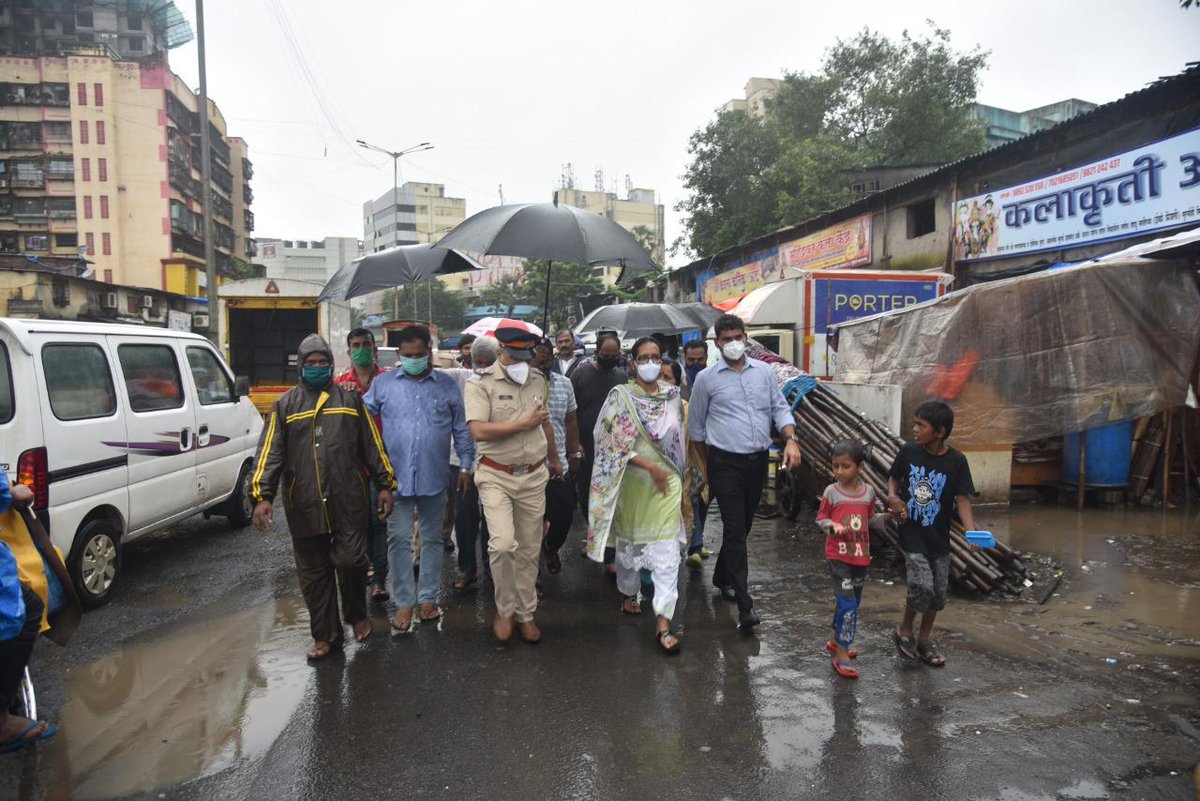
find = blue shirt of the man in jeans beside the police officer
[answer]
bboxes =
[362,369,475,496]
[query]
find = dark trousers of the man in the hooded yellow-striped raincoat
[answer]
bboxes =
[292,529,367,646]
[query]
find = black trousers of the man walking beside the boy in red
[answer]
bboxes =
[708,446,767,612]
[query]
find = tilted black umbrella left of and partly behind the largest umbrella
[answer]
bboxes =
[317,245,484,303]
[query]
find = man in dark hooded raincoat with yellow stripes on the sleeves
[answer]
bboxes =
[251,333,396,662]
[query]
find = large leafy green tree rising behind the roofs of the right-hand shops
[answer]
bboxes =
[673,23,988,255]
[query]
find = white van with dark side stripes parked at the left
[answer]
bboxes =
[0,318,263,607]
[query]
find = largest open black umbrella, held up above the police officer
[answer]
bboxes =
[438,201,658,330]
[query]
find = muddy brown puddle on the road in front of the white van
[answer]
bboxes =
[49,598,312,799]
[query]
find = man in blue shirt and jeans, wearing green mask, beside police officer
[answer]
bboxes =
[362,325,475,634]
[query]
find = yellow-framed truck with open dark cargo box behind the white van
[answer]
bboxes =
[217,278,350,415]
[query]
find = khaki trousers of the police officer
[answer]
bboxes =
[475,464,550,622]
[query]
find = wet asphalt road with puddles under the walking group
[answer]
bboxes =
[0,501,1200,801]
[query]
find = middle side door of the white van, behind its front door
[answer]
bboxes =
[107,336,199,532]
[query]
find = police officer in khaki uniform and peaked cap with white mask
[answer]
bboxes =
[464,327,563,644]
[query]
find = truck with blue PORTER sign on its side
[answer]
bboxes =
[731,270,953,378]
